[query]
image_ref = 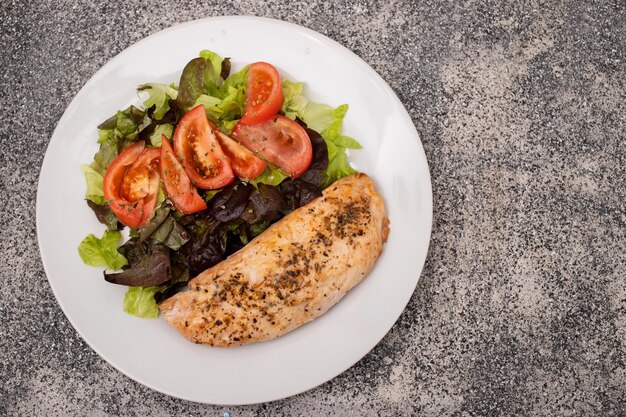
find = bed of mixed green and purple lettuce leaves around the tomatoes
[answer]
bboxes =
[78,50,361,318]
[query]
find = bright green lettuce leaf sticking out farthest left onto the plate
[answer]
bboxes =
[78,230,128,270]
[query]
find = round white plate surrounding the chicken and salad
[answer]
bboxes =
[37,17,432,405]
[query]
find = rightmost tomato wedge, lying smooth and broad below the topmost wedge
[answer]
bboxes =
[232,115,313,178]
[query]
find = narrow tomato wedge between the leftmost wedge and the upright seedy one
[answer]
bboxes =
[161,135,206,214]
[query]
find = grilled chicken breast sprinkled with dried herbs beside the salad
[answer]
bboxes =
[160,174,389,347]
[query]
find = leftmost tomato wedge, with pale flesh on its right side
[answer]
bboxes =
[102,141,161,228]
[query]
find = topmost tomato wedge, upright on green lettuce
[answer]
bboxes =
[241,62,283,124]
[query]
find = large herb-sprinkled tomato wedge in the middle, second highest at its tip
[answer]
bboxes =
[174,104,235,189]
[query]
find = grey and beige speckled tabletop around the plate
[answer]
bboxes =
[0,0,626,416]
